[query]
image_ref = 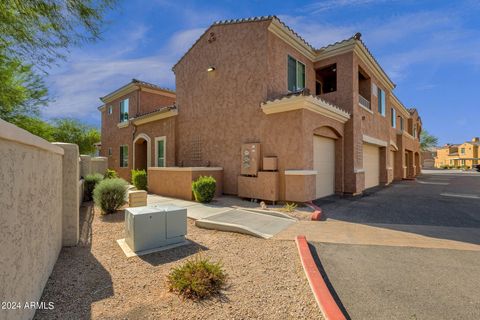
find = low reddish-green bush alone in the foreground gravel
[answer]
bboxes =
[167,256,227,300]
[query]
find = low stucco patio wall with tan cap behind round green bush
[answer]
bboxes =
[147,167,223,200]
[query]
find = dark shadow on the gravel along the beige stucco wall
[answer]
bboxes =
[34,202,113,319]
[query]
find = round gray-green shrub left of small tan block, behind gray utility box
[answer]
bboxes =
[93,178,128,214]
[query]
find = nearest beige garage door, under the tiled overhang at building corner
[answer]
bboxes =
[313,136,335,198]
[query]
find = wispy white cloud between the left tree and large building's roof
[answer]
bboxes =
[43,27,204,123]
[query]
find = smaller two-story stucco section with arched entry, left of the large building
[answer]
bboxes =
[98,79,177,180]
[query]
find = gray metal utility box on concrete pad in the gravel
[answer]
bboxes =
[125,204,187,252]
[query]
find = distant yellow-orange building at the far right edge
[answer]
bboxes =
[435,137,480,168]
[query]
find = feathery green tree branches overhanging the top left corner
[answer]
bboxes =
[0,0,116,124]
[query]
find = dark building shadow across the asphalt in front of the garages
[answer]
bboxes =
[314,177,480,245]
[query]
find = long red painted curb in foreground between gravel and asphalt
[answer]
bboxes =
[295,236,346,320]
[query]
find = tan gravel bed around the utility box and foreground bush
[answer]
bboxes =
[35,203,321,319]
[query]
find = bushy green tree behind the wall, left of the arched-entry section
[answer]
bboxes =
[52,118,100,154]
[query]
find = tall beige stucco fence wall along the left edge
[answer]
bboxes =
[0,119,81,319]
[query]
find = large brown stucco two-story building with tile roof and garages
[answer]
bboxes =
[101,17,422,201]
